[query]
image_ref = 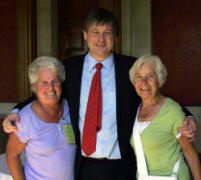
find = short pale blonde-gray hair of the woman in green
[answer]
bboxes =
[129,55,167,87]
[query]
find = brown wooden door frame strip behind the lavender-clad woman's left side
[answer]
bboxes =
[16,0,37,102]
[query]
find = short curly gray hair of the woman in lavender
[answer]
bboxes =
[28,56,66,92]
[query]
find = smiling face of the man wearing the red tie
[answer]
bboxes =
[84,23,115,61]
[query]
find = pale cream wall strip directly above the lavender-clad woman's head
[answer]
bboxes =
[37,0,58,57]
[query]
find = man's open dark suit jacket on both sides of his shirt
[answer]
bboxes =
[63,53,140,179]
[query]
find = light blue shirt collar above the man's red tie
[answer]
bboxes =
[86,53,114,71]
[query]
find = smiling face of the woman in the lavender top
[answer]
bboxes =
[34,68,61,105]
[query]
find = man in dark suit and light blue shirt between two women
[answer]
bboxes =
[2,9,197,180]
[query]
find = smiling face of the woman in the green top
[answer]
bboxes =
[134,63,159,100]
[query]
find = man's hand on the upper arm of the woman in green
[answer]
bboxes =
[178,117,198,142]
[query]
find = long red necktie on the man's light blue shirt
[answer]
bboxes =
[82,63,102,156]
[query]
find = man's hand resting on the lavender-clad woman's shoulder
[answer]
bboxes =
[2,113,19,133]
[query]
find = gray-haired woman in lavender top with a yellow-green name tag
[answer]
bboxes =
[6,57,76,180]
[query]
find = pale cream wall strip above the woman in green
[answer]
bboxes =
[121,0,152,57]
